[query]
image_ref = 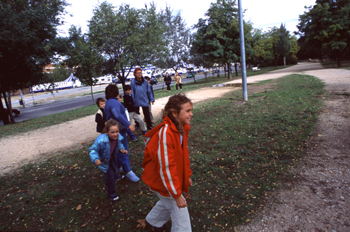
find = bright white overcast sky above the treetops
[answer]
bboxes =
[59,0,315,36]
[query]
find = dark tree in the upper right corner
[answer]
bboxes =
[296,0,350,67]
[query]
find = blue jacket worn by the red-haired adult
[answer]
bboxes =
[130,77,154,107]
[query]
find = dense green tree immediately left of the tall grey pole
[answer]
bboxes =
[191,0,252,79]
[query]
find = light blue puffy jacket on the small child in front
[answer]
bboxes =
[89,134,125,172]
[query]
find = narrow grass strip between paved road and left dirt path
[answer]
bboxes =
[0,66,290,138]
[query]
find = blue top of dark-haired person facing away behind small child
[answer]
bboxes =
[104,98,130,132]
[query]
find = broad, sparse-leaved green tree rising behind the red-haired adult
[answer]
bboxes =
[88,2,165,87]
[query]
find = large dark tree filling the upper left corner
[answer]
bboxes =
[0,0,67,124]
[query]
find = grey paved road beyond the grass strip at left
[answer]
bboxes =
[0,71,224,126]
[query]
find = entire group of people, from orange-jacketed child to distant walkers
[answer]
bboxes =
[89,68,193,231]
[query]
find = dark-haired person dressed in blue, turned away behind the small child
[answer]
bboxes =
[105,84,140,182]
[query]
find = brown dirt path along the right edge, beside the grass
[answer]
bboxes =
[236,69,350,232]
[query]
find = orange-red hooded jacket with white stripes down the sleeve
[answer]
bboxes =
[142,116,192,198]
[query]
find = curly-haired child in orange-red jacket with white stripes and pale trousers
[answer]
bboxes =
[138,93,193,231]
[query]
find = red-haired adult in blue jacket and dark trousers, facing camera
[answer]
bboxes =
[130,68,154,130]
